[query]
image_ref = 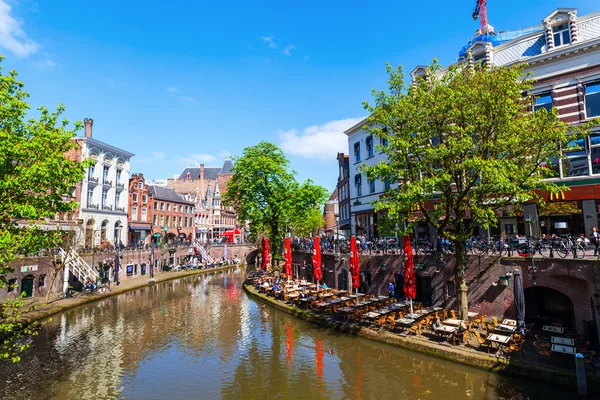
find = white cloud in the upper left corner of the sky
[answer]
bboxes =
[0,0,40,57]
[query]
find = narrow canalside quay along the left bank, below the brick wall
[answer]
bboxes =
[20,265,244,324]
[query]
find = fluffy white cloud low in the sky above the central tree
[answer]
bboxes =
[281,118,363,160]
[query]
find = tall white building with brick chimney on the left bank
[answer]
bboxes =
[77,118,134,246]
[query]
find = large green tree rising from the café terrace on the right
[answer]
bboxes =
[364,61,589,319]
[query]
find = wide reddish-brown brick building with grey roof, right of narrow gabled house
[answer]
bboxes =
[149,183,195,242]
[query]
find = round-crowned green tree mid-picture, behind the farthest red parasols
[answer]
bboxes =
[223,141,327,260]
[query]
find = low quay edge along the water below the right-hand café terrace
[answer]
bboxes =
[243,284,600,393]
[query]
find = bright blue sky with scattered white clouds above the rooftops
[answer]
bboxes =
[0,0,600,189]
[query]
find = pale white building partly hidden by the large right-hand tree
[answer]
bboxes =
[344,119,398,238]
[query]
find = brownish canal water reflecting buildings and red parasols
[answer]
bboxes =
[0,267,575,400]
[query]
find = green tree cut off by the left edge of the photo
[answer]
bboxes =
[0,56,84,362]
